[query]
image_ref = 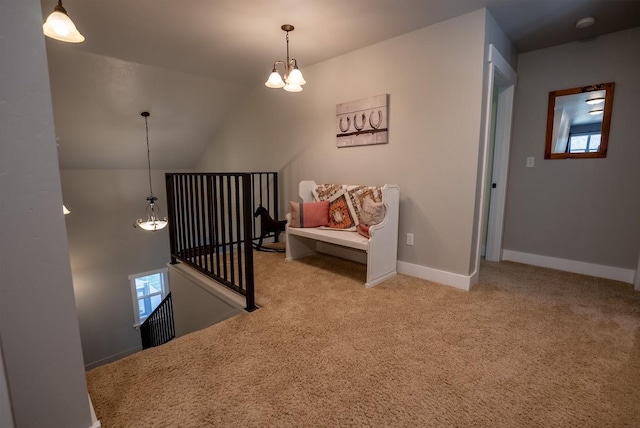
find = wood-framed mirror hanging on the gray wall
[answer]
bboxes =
[544,82,615,159]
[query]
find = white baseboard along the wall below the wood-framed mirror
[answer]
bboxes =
[502,250,636,284]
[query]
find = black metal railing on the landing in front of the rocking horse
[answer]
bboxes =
[165,173,256,311]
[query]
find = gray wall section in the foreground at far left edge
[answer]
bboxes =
[0,0,91,428]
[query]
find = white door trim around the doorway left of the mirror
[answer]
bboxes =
[471,44,517,279]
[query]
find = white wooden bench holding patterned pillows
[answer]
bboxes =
[286,181,400,287]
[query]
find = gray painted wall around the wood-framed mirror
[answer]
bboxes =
[504,28,640,270]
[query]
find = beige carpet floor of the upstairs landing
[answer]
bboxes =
[87,252,640,428]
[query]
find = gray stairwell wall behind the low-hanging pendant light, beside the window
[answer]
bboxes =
[61,169,170,368]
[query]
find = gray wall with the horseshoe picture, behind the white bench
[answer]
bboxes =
[197,10,496,275]
